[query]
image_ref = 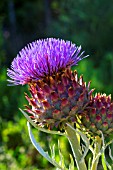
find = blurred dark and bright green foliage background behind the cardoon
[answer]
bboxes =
[0,0,113,170]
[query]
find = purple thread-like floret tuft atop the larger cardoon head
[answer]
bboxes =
[7,38,86,85]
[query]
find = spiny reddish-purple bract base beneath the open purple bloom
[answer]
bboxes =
[26,69,92,129]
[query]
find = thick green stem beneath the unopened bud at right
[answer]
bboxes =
[91,136,102,170]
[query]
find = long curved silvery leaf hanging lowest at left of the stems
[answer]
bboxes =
[27,122,64,170]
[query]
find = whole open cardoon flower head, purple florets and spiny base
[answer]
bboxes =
[8,38,92,129]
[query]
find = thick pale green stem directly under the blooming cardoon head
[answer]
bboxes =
[65,123,87,170]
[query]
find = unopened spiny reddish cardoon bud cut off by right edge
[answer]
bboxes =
[81,93,113,136]
